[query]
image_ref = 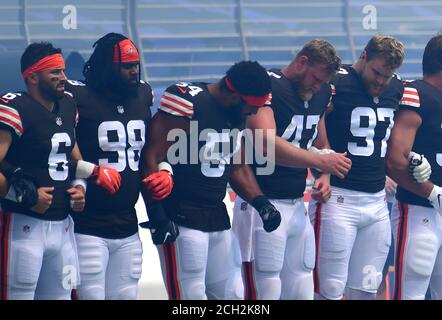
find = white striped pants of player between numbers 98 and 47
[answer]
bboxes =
[157,226,244,300]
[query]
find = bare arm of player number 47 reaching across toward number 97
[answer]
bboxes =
[247,107,351,178]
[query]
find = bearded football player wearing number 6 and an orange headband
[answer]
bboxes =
[0,43,118,299]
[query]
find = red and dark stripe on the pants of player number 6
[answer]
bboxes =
[0,209,11,300]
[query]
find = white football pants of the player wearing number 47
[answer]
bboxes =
[232,197,315,300]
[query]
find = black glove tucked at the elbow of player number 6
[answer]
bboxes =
[5,168,38,208]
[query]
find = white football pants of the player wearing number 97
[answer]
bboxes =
[309,187,391,300]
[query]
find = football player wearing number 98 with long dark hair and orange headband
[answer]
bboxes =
[66,33,158,299]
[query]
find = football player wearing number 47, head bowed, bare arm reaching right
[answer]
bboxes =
[233,40,351,299]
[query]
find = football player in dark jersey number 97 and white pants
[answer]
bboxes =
[309,35,404,300]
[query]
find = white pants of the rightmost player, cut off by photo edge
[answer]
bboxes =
[391,202,442,300]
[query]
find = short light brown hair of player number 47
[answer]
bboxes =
[296,39,341,73]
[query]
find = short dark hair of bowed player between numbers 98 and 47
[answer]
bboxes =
[221,61,271,97]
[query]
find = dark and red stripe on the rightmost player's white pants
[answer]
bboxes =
[393,201,408,300]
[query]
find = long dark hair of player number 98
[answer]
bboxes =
[83,32,141,92]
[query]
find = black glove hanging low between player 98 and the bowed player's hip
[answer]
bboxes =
[140,202,180,245]
